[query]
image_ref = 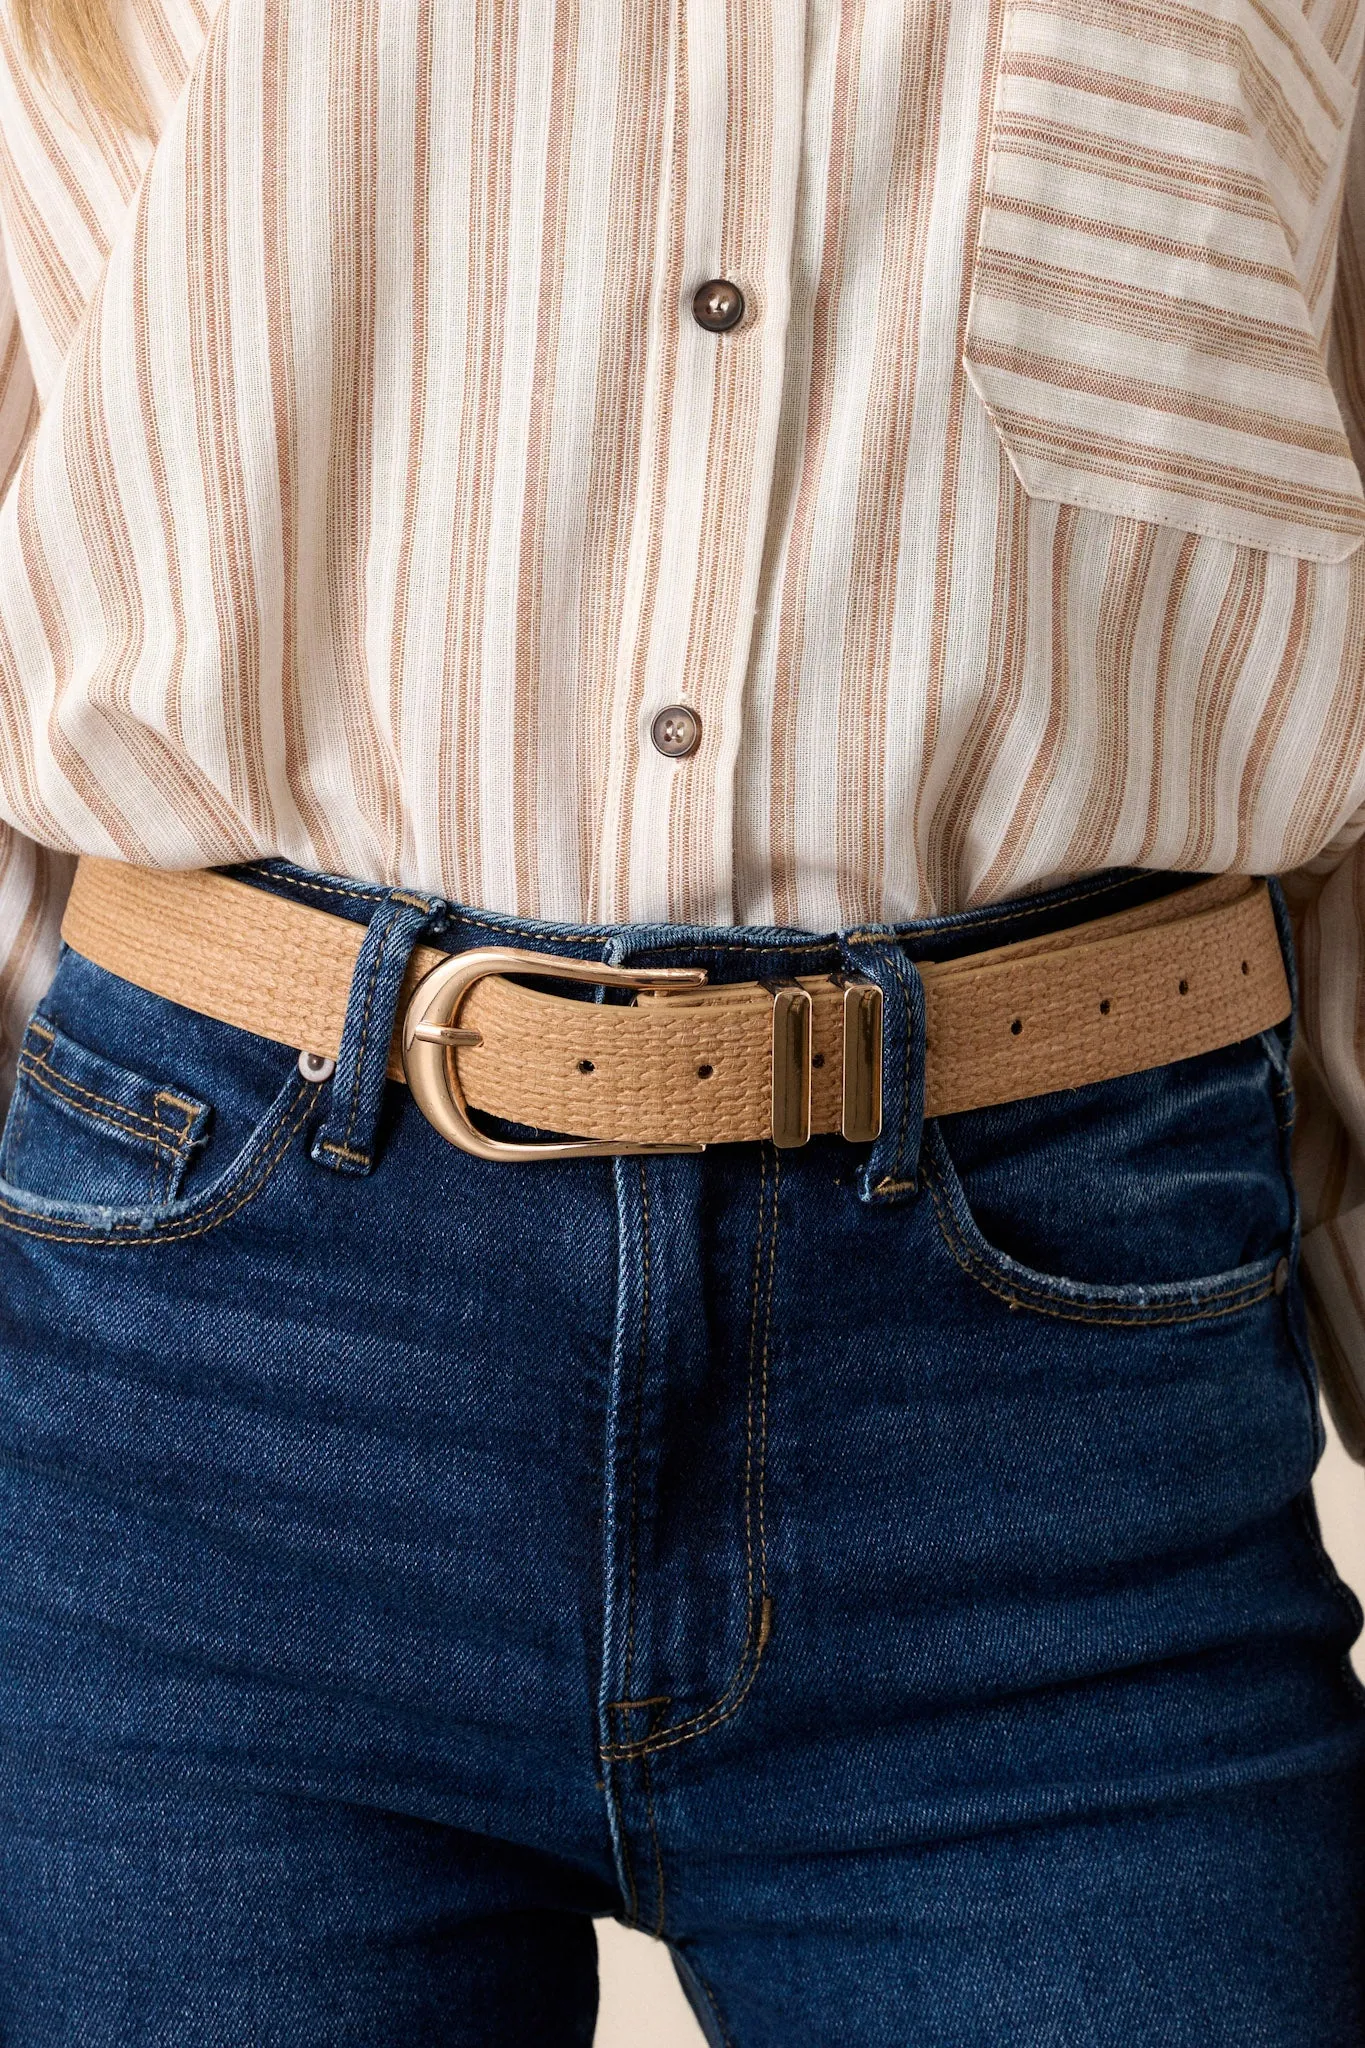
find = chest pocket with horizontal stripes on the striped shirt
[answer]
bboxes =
[966,0,1365,561]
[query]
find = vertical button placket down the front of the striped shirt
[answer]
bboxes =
[596,0,804,924]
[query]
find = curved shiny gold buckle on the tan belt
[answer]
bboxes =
[403,946,706,1161]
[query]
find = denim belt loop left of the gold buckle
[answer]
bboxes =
[313,889,444,1174]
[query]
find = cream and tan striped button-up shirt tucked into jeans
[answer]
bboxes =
[0,0,1365,1441]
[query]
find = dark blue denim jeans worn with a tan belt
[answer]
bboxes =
[0,870,1365,2048]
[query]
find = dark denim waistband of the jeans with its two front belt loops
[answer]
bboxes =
[227,860,1227,1202]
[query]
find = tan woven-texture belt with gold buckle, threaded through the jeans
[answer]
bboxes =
[61,860,1289,1159]
